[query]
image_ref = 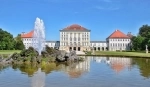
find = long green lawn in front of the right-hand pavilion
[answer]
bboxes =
[95,51,150,57]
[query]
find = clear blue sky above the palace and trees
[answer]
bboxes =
[0,0,150,41]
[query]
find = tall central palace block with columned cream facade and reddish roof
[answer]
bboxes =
[60,24,90,51]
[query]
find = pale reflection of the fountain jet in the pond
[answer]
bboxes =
[31,68,45,87]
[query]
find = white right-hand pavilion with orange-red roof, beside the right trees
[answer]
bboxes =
[106,30,131,51]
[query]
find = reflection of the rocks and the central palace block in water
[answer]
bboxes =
[9,58,90,78]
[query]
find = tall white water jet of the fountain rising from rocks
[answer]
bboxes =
[32,18,45,55]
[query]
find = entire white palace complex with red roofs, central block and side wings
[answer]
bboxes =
[21,24,132,52]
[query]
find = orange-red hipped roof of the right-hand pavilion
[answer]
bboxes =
[108,30,130,38]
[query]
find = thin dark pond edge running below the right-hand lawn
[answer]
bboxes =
[78,55,150,58]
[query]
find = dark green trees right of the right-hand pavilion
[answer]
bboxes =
[131,25,150,51]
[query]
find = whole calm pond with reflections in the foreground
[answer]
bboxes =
[0,56,150,87]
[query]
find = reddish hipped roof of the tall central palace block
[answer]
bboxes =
[62,24,89,31]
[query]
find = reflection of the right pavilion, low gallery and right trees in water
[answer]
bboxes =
[92,57,150,78]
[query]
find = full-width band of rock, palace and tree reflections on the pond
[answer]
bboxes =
[9,57,150,78]
